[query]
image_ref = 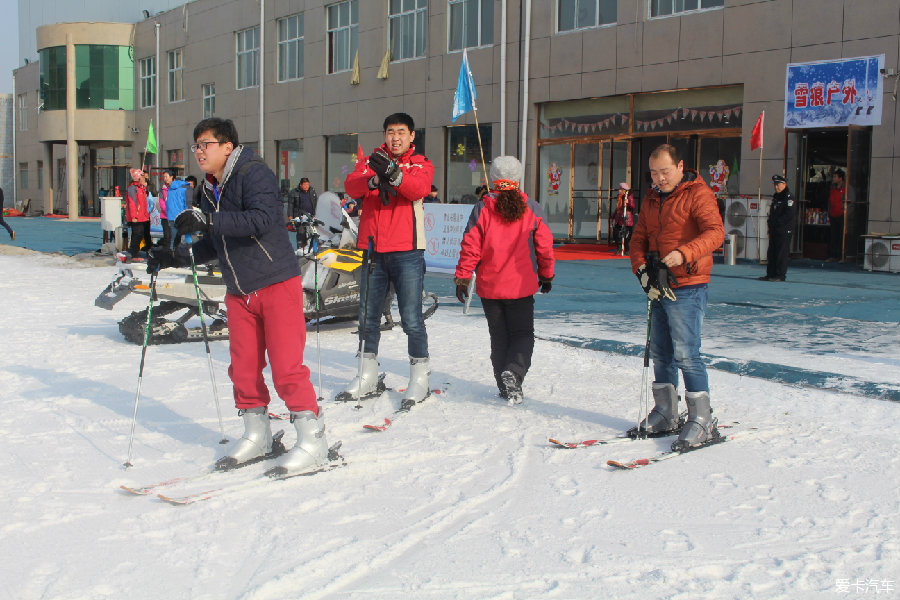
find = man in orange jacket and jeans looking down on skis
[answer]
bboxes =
[631,144,725,450]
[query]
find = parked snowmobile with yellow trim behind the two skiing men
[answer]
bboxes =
[94,192,438,344]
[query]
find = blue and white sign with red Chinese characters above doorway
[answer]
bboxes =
[784,54,884,129]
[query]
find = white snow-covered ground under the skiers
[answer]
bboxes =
[0,249,900,600]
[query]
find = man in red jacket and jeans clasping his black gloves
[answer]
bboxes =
[338,113,434,406]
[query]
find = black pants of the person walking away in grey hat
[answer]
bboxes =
[481,296,534,389]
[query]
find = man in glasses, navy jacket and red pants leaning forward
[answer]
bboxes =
[148,118,328,473]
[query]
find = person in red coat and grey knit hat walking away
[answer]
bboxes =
[454,156,554,404]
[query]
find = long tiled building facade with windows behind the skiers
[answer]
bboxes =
[16,0,900,261]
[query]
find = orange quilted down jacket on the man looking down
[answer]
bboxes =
[630,169,725,287]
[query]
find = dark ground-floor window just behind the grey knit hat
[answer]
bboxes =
[444,125,493,204]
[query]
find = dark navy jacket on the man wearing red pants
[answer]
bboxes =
[178,146,301,296]
